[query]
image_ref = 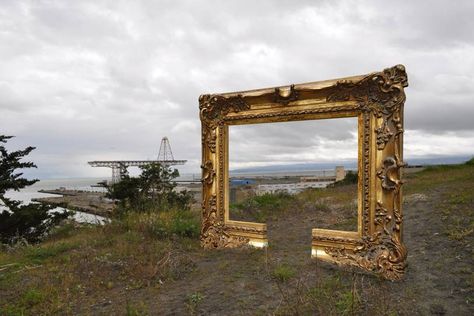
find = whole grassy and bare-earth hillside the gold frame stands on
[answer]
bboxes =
[0,160,474,315]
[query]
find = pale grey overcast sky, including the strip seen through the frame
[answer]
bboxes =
[0,0,474,178]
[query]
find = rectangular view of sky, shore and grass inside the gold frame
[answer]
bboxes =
[227,117,358,231]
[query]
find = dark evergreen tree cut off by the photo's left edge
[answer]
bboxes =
[0,135,71,243]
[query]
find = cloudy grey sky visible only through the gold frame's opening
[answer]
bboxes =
[229,118,357,167]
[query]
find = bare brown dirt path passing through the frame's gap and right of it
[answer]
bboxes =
[62,175,474,316]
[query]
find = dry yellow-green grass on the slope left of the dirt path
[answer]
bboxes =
[0,218,198,315]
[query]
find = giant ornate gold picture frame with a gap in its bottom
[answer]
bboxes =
[199,65,408,280]
